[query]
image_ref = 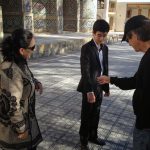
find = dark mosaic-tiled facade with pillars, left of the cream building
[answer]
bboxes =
[0,0,97,33]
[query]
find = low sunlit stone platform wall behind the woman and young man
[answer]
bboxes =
[0,33,120,61]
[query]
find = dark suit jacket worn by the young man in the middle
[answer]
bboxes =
[77,40,109,93]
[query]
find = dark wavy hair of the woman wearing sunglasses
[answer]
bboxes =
[1,28,33,63]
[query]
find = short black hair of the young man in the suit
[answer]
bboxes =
[93,19,110,33]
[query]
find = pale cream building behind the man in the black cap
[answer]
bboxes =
[97,0,150,32]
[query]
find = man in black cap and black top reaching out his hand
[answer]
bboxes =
[98,15,150,150]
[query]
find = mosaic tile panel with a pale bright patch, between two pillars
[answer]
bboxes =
[32,0,57,32]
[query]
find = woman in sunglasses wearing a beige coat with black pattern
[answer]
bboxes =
[0,29,42,150]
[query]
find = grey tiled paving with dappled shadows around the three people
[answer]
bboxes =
[27,43,141,150]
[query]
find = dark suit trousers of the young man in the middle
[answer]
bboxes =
[79,88,102,145]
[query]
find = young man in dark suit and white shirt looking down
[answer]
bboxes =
[77,19,109,150]
